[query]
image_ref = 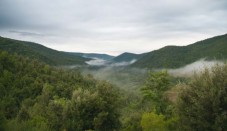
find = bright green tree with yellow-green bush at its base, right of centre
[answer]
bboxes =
[141,71,178,131]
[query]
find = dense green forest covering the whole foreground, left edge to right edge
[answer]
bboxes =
[0,51,227,131]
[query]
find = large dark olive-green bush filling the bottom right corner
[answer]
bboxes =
[178,65,227,131]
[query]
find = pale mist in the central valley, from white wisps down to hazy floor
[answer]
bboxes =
[82,59,147,91]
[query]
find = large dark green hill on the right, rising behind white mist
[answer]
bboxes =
[132,34,227,68]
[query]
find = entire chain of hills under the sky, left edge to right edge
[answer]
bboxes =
[0,34,227,68]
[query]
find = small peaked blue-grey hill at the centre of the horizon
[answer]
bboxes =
[112,52,144,62]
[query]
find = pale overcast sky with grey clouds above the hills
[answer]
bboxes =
[0,0,227,55]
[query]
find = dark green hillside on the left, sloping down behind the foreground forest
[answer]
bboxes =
[0,37,90,65]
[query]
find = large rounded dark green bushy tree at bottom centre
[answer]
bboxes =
[72,83,120,131]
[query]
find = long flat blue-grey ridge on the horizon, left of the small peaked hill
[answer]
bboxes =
[69,52,114,60]
